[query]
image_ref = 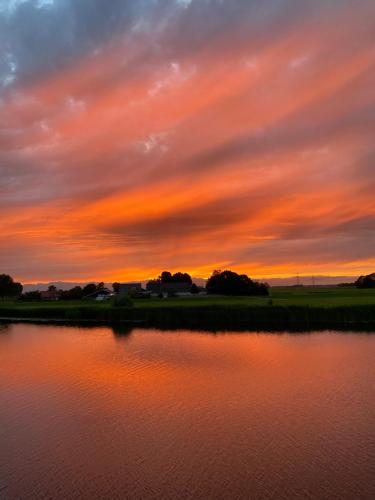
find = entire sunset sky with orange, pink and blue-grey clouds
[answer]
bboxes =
[0,0,375,282]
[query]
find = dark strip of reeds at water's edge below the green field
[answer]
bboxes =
[4,306,375,331]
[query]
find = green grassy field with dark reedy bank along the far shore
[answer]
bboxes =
[0,287,375,331]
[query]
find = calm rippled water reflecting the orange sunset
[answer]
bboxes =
[0,325,375,499]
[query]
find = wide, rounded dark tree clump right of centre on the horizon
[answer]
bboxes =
[206,270,268,295]
